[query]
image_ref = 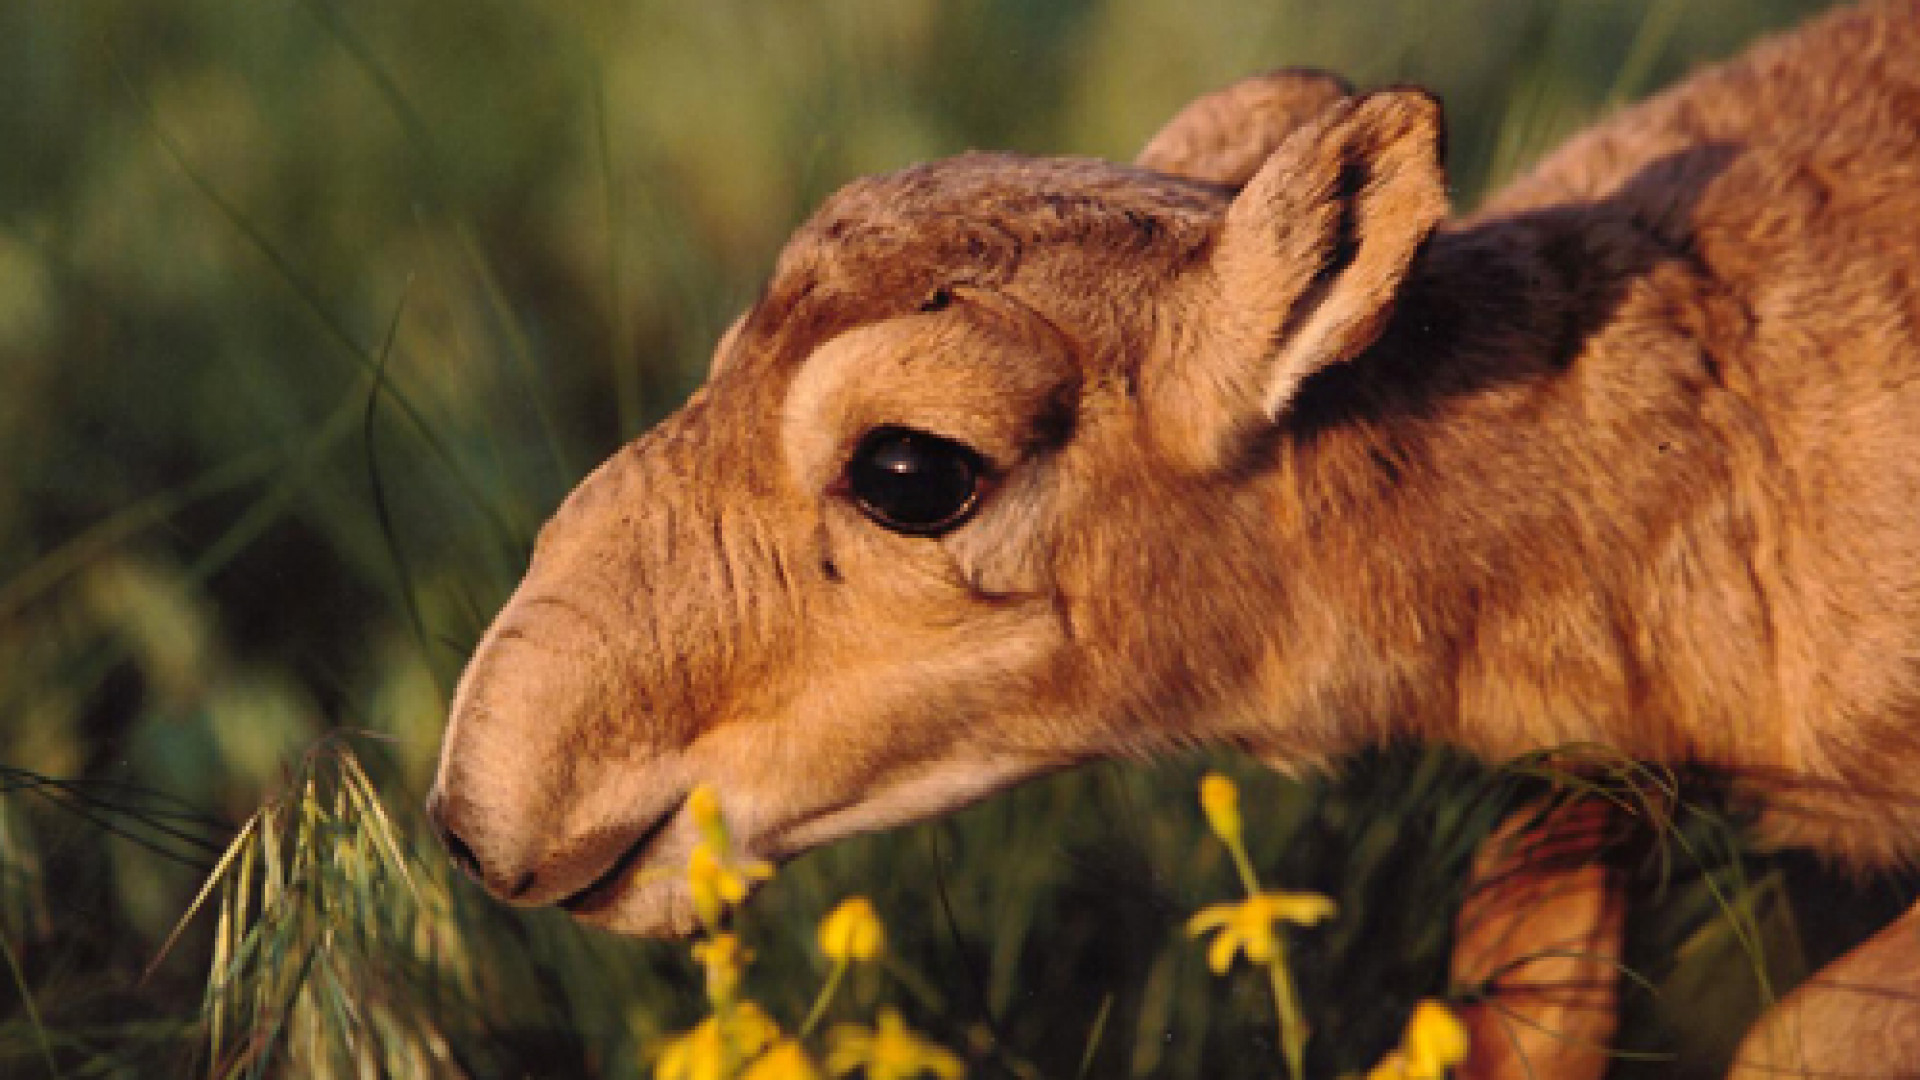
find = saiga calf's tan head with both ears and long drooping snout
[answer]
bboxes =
[432,73,1446,934]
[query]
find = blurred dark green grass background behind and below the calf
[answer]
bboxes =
[0,0,1858,1076]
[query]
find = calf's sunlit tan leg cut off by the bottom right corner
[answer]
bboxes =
[1732,891,1920,1080]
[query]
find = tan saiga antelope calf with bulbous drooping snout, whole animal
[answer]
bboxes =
[432,0,1920,1074]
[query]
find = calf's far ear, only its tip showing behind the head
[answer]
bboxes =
[1133,67,1354,188]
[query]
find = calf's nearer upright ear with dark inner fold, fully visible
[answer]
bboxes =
[1162,90,1448,465]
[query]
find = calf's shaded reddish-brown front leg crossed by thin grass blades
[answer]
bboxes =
[1452,799,1626,1080]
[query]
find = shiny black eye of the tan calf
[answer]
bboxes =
[847,427,987,536]
